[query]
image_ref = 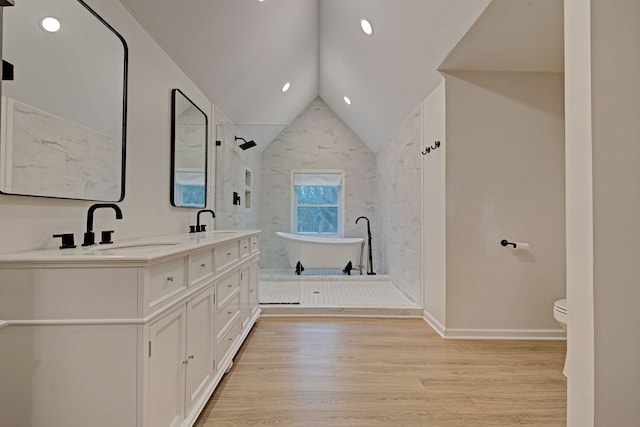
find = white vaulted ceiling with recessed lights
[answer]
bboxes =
[120,0,562,151]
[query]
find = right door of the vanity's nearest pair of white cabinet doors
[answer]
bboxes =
[185,285,215,413]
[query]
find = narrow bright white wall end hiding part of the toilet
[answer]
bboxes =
[564,0,596,427]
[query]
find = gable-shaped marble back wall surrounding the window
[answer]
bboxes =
[259,98,376,268]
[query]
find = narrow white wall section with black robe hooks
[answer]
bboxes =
[422,80,447,334]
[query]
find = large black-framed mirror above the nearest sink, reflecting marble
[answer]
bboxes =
[0,0,128,202]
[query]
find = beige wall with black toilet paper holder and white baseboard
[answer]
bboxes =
[445,72,565,338]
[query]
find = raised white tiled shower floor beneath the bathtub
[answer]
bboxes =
[258,270,422,316]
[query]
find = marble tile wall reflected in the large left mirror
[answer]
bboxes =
[3,98,122,200]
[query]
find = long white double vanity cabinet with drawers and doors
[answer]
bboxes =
[0,231,260,427]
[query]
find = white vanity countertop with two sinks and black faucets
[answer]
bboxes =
[0,230,260,268]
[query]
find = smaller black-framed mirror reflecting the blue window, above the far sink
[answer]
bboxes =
[171,89,209,208]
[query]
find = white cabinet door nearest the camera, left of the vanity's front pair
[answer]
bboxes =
[151,305,185,427]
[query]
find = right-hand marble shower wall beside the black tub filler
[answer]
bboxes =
[373,105,422,303]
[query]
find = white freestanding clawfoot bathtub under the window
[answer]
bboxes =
[276,231,364,270]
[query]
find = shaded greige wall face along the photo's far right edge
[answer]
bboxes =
[592,0,640,427]
